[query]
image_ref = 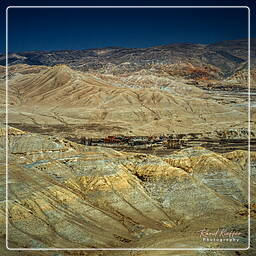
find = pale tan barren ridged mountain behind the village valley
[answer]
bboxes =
[2,64,250,137]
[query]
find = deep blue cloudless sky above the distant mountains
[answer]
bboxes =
[1,1,254,52]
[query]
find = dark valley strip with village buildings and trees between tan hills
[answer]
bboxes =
[62,129,254,153]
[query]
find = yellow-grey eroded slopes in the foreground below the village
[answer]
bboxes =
[1,125,255,255]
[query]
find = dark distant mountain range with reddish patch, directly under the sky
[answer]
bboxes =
[0,39,256,79]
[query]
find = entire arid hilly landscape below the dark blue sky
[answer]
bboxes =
[0,40,256,256]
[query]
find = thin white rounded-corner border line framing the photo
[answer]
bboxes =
[5,6,251,251]
